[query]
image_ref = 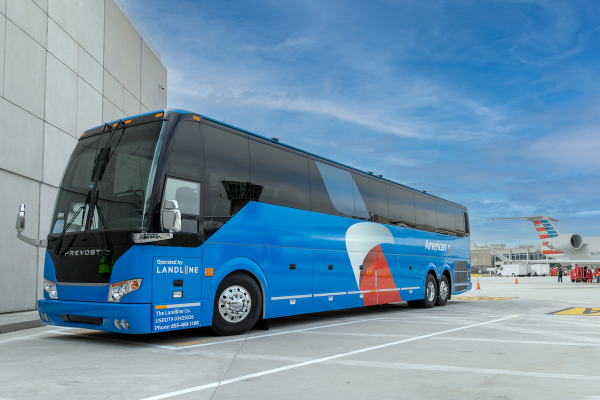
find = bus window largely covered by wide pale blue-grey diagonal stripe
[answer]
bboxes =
[308,160,354,217]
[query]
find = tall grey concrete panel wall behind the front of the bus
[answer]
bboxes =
[0,0,167,313]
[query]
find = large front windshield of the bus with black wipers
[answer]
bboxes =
[52,121,166,233]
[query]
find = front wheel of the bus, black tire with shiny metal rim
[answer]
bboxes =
[211,272,262,335]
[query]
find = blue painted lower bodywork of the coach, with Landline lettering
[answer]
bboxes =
[40,202,471,333]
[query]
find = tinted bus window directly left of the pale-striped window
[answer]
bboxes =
[250,140,310,210]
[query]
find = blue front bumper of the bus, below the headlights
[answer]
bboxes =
[38,300,152,334]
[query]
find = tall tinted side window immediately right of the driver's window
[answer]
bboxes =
[202,125,250,236]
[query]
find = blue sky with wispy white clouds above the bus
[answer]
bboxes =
[122,0,600,245]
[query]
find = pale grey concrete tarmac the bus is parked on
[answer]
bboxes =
[0,277,600,400]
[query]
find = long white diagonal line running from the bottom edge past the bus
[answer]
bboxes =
[143,315,516,400]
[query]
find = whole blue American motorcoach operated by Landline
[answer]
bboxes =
[17,110,471,335]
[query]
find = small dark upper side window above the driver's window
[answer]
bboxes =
[169,121,202,180]
